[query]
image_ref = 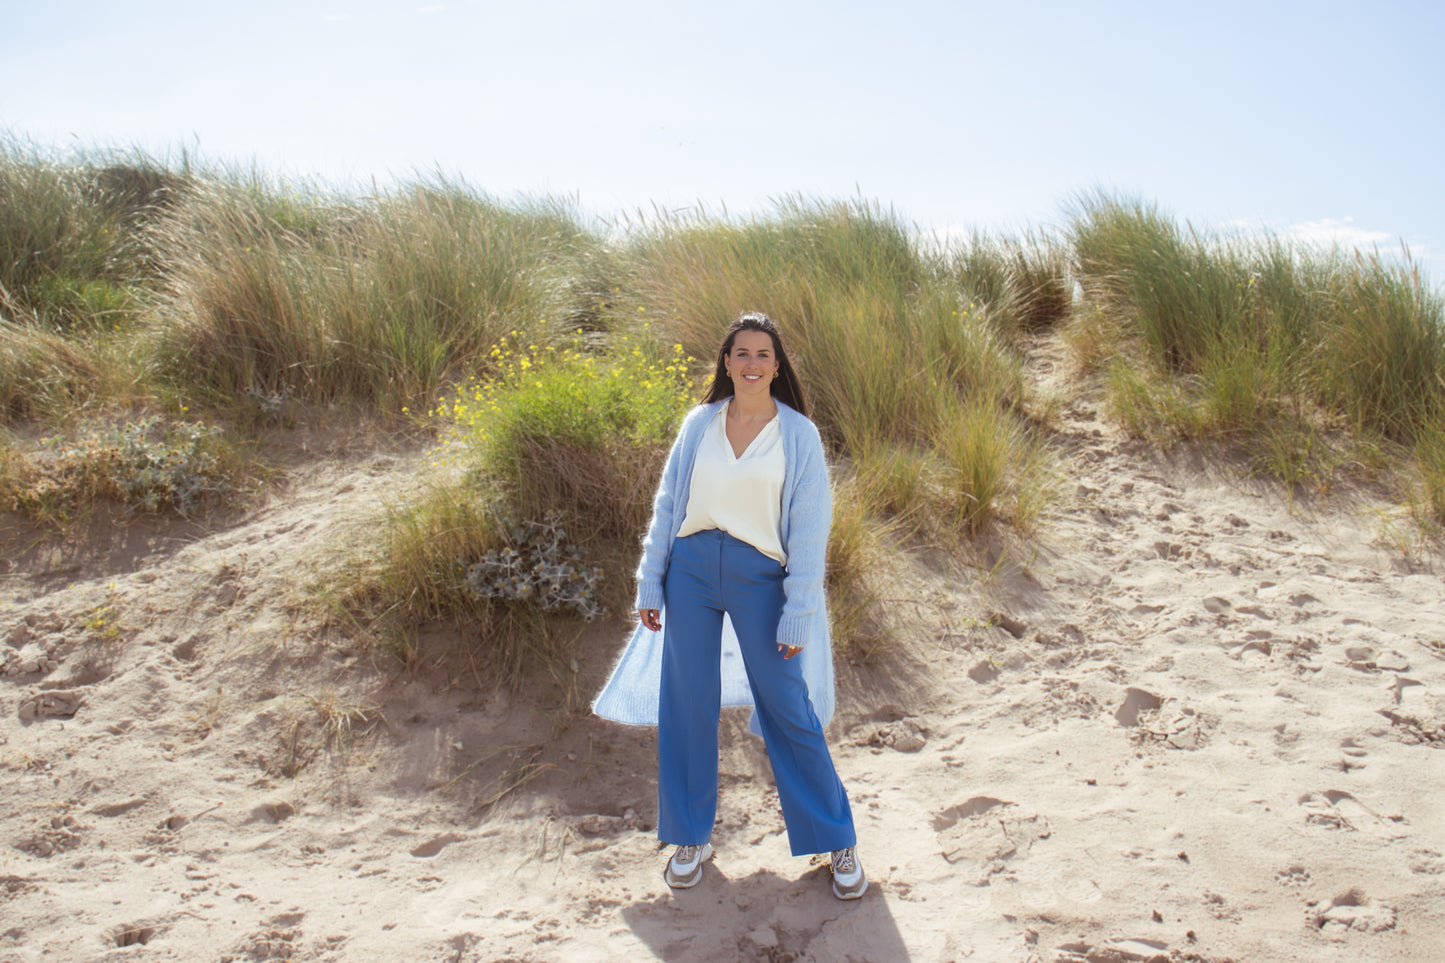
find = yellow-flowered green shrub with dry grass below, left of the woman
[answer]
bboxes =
[338,331,692,685]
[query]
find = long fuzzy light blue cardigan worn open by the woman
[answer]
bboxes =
[592,402,835,732]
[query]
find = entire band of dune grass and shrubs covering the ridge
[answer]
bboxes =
[0,139,1445,681]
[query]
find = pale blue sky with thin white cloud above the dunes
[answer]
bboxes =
[0,0,1445,286]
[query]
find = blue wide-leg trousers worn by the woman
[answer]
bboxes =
[657,529,857,856]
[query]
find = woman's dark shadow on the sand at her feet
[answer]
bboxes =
[621,862,909,963]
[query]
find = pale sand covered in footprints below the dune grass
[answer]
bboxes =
[0,341,1445,963]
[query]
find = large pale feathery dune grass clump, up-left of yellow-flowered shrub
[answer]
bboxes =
[143,175,597,411]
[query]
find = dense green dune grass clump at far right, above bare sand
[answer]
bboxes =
[1069,195,1445,517]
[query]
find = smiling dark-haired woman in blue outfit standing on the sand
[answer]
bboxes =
[594,314,868,899]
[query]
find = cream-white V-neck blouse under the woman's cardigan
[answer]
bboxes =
[678,399,788,565]
